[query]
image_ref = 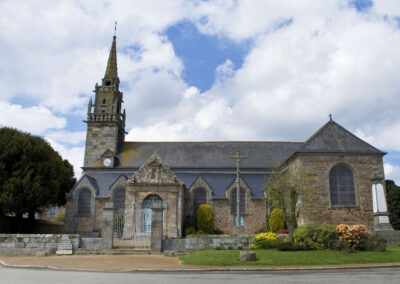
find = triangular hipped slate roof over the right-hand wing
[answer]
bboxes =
[296,120,385,155]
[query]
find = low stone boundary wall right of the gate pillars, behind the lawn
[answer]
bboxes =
[162,235,255,252]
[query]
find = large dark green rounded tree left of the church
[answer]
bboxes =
[0,127,76,230]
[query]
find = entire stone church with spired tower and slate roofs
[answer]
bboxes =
[65,36,387,238]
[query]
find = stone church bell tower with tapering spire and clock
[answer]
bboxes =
[83,35,126,167]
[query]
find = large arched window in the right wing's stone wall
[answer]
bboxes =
[329,165,356,206]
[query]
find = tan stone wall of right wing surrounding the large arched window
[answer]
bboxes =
[288,153,383,228]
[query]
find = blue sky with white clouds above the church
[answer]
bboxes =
[0,0,400,184]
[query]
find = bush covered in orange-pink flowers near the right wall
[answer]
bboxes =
[336,224,373,250]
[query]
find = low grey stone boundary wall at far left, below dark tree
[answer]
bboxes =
[0,234,79,256]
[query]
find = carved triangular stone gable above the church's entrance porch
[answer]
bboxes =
[128,153,183,185]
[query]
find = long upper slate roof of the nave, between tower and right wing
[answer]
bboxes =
[118,142,303,169]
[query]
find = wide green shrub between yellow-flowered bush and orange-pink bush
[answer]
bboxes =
[293,224,339,250]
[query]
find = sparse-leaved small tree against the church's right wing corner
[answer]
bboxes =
[264,169,314,244]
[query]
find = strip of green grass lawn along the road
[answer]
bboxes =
[180,247,400,266]
